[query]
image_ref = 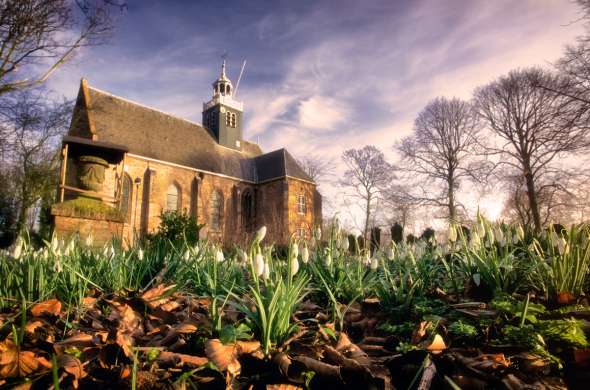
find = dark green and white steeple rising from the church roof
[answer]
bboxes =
[203,59,244,150]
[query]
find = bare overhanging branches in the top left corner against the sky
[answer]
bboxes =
[0,0,125,94]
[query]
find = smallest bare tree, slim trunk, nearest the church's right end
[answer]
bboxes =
[340,145,393,239]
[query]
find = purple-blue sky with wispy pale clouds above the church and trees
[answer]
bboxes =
[49,0,584,232]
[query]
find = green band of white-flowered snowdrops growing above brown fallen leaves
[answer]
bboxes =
[0,219,590,382]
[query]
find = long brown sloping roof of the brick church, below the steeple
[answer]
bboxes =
[68,80,312,182]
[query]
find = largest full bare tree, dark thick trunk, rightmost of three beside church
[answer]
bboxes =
[475,68,590,230]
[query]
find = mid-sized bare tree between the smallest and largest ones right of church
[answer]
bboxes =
[395,97,482,221]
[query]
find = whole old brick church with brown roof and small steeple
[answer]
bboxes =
[52,61,321,246]
